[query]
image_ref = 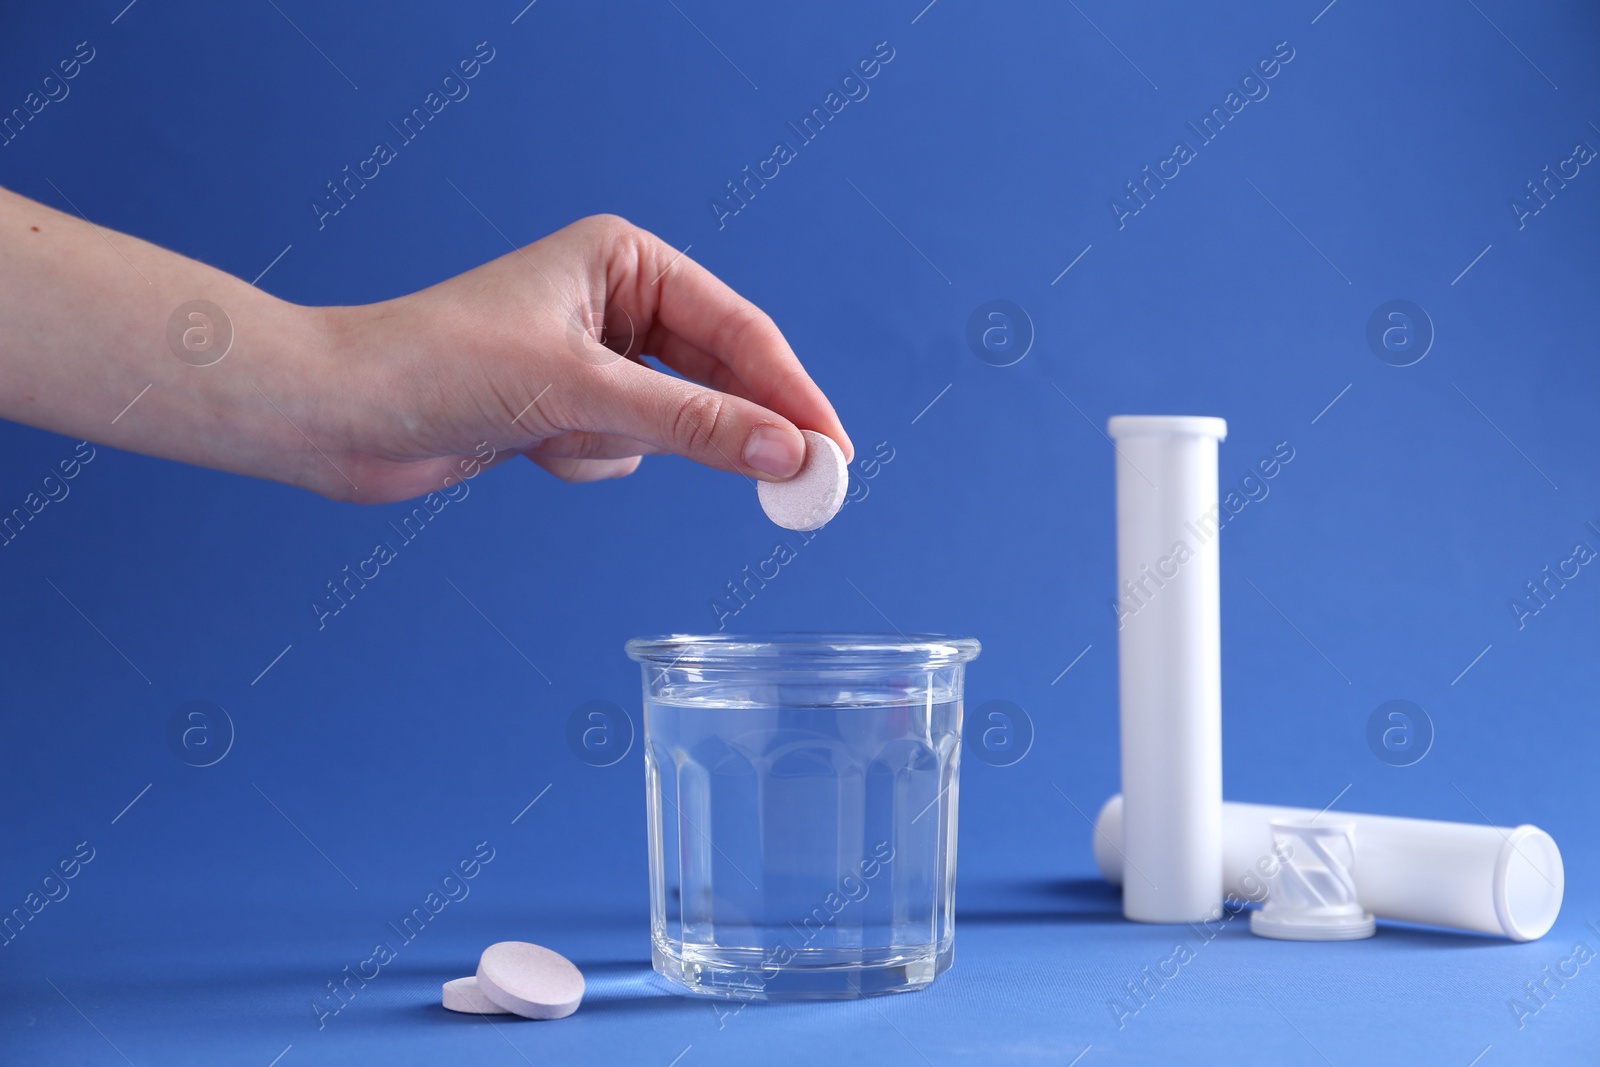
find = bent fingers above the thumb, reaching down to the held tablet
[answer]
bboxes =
[576,219,854,463]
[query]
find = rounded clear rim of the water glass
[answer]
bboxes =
[624,632,982,669]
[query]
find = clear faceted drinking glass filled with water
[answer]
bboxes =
[627,633,978,1000]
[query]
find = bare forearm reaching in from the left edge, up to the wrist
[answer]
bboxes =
[0,182,358,499]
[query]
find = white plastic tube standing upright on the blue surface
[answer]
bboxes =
[1106,414,1227,923]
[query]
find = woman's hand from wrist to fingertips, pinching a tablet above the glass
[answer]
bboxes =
[314,216,853,501]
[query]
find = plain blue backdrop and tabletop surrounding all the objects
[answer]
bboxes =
[0,0,1600,1067]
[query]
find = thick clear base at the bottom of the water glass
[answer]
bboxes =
[650,939,955,1000]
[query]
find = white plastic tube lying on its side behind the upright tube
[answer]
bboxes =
[1094,793,1566,941]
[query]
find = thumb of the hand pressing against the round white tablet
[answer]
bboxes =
[582,360,805,482]
